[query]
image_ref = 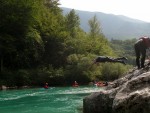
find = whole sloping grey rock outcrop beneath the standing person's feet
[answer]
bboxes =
[83,67,150,113]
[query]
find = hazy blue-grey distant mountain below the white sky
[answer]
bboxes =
[61,7,150,40]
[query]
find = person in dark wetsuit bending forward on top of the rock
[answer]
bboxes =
[134,36,150,69]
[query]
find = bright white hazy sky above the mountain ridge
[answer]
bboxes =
[59,0,150,22]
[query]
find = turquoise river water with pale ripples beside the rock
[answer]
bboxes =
[0,86,102,113]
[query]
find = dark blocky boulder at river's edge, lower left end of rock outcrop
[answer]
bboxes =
[83,89,117,113]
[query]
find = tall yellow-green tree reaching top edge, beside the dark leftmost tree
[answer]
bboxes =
[40,0,68,68]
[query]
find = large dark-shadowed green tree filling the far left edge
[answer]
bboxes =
[0,0,42,69]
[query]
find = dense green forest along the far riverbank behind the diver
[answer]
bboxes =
[0,0,136,87]
